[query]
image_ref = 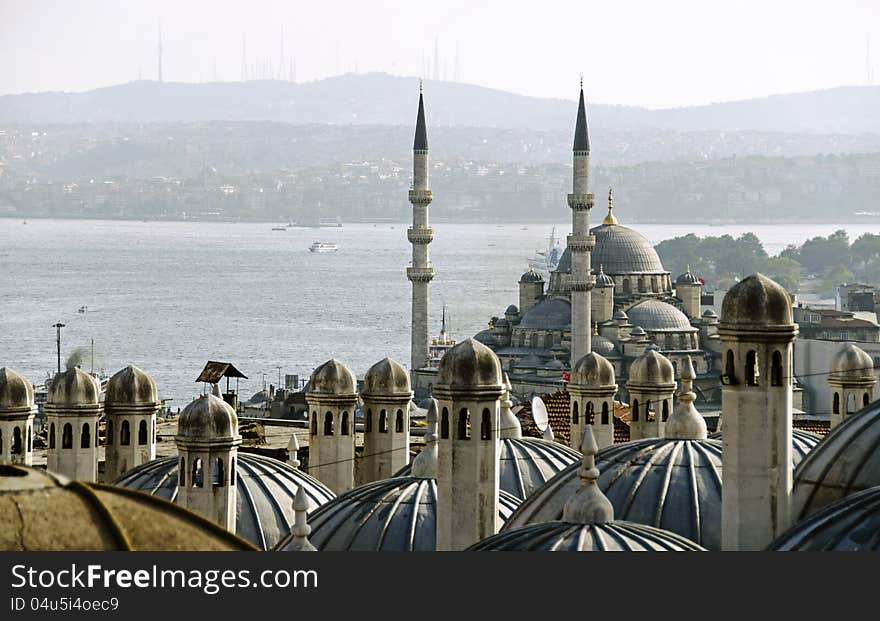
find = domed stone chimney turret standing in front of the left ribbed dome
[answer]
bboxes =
[174,392,241,533]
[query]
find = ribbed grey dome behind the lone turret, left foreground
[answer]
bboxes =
[113,452,336,550]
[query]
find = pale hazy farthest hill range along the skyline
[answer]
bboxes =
[0,73,880,134]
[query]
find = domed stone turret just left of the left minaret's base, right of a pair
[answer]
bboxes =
[360,358,413,483]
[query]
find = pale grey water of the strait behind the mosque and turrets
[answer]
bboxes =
[0,218,877,408]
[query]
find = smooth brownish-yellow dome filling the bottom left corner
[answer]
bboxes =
[0,464,256,551]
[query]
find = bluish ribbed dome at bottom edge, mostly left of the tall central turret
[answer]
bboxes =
[275,477,519,552]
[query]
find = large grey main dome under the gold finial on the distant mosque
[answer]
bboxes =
[590,224,666,274]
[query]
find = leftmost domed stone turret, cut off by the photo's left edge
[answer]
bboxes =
[0,367,37,466]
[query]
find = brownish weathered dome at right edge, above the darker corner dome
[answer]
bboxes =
[791,401,880,522]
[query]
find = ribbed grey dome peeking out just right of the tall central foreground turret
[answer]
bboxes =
[394,437,581,500]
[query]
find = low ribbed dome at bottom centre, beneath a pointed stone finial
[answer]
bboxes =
[468,521,705,552]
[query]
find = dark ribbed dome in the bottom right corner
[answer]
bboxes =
[769,487,880,552]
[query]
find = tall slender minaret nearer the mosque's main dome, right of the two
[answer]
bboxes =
[567,79,596,365]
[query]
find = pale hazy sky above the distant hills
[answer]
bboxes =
[0,0,880,108]
